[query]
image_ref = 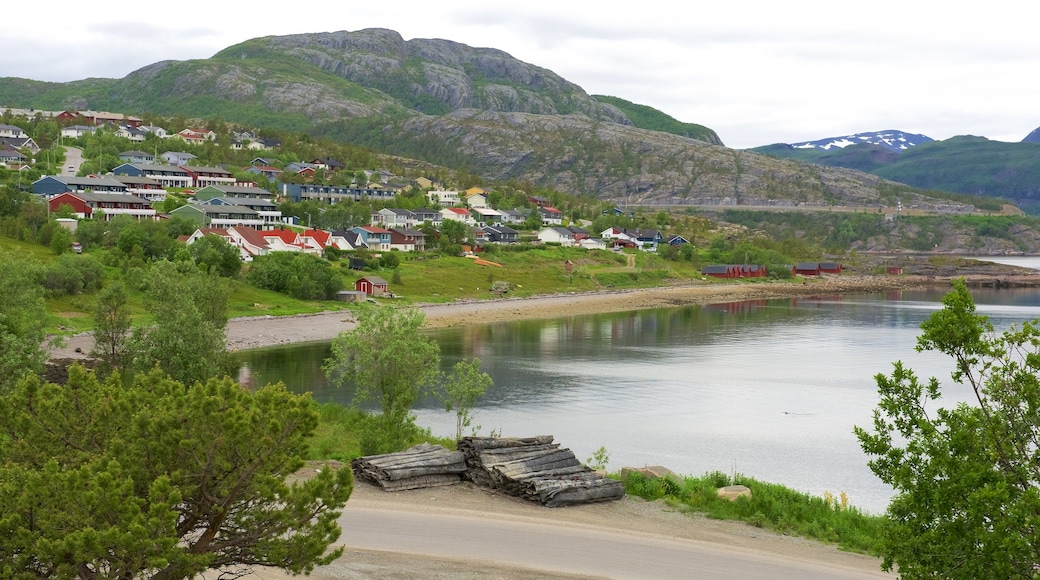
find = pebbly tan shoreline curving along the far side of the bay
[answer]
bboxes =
[49,274,1040,360]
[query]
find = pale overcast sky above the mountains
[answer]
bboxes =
[0,0,1040,149]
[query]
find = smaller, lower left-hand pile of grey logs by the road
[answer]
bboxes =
[350,443,467,492]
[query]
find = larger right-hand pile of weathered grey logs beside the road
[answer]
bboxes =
[459,436,625,507]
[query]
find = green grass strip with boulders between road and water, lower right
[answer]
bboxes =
[624,472,885,554]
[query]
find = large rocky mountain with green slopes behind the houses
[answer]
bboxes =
[0,29,981,214]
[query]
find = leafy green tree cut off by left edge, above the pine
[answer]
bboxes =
[0,252,49,393]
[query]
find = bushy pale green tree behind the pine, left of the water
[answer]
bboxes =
[129,261,228,385]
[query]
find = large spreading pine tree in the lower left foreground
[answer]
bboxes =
[0,366,353,579]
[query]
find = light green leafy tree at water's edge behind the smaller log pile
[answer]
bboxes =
[322,305,440,424]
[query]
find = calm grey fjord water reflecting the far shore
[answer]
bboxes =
[236,280,1040,512]
